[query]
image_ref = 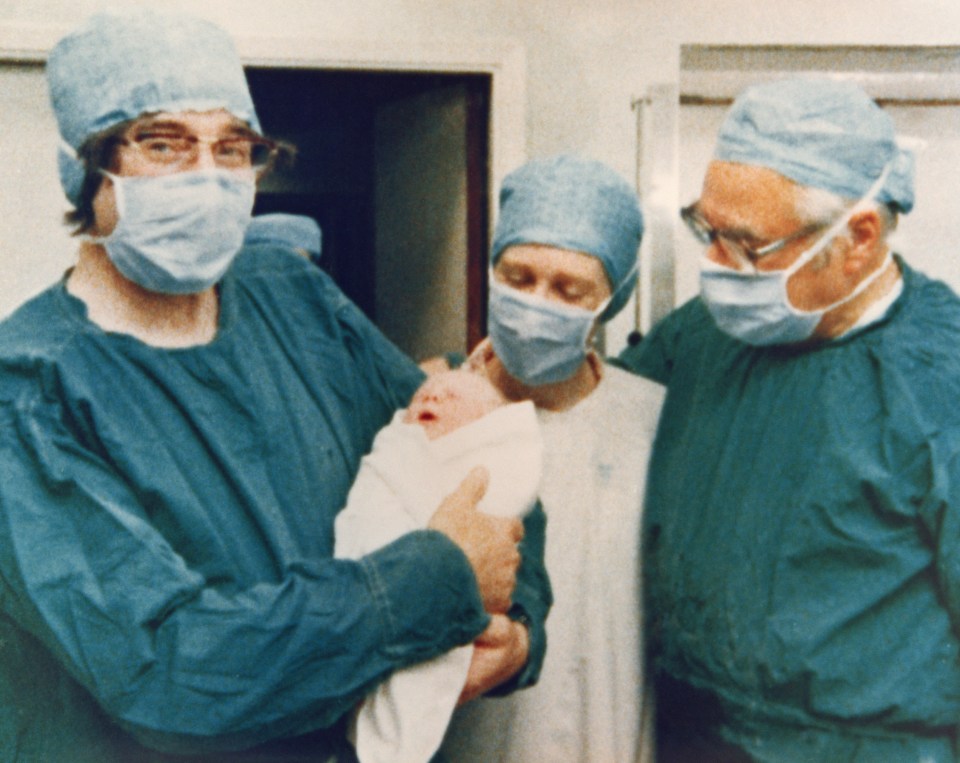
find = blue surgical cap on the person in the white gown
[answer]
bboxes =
[490,154,643,321]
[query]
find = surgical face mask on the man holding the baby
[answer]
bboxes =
[89,169,256,294]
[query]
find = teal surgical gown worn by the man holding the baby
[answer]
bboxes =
[0,249,549,763]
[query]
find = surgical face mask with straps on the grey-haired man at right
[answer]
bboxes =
[700,166,891,346]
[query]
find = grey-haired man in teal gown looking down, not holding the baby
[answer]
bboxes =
[620,78,960,763]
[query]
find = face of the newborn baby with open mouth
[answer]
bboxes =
[403,371,503,440]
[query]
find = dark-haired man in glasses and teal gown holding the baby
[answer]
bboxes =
[0,10,549,763]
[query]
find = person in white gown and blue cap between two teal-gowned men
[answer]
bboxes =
[444,154,663,763]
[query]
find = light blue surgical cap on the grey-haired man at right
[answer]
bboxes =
[714,78,913,212]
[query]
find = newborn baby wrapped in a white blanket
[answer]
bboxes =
[335,370,543,763]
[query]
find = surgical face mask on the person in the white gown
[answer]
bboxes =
[487,266,636,387]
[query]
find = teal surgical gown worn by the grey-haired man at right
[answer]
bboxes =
[620,260,960,763]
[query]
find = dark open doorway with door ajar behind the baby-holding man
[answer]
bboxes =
[247,67,491,359]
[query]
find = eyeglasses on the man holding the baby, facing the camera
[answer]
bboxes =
[120,129,277,172]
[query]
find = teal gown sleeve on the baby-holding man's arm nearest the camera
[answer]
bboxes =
[0,396,488,752]
